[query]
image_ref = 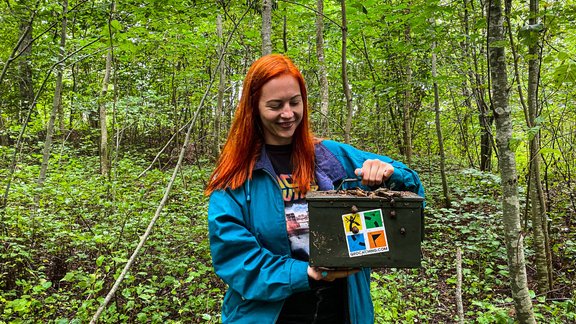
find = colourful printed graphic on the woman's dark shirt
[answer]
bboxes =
[277,174,318,261]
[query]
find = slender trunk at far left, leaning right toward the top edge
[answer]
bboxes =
[35,0,68,192]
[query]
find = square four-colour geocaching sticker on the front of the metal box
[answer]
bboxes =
[342,209,388,258]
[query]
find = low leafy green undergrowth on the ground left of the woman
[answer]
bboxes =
[0,150,223,322]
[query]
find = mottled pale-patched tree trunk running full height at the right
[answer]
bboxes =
[488,0,536,323]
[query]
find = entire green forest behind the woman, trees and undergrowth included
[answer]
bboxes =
[0,0,576,323]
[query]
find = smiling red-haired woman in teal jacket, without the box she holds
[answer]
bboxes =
[206,55,424,323]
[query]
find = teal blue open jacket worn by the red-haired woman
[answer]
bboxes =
[208,140,424,324]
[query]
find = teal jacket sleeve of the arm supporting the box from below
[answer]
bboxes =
[208,190,310,301]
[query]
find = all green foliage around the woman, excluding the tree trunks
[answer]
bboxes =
[0,0,576,323]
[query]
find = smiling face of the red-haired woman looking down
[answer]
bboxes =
[258,75,304,145]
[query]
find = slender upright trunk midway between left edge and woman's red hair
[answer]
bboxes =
[98,1,116,177]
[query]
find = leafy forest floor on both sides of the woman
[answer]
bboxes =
[0,152,576,323]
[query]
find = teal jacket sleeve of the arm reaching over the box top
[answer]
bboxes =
[322,140,424,197]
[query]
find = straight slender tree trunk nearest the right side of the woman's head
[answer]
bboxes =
[316,0,330,136]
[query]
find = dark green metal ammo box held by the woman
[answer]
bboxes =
[306,189,424,268]
